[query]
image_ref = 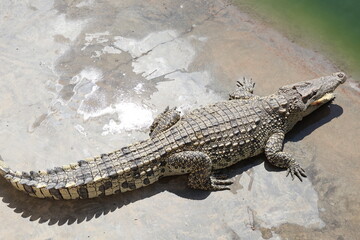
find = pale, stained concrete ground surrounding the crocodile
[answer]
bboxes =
[0,0,360,240]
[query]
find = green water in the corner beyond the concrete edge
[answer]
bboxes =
[233,0,360,78]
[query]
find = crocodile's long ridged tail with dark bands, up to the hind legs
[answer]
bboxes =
[0,140,159,200]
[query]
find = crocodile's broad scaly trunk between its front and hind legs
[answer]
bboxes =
[164,95,284,169]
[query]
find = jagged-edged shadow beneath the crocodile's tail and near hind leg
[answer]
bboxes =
[0,172,210,226]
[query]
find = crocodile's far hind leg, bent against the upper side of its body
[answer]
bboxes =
[149,106,180,137]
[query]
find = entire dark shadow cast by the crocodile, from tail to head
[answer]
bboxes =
[0,104,343,226]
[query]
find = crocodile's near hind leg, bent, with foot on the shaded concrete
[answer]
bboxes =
[167,151,233,190]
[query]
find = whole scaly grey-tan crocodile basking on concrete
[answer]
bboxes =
[0,72,346,200]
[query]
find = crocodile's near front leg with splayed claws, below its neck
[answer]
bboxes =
[265,132,306,181]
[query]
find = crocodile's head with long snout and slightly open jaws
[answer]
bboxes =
[278,72,346,129]
